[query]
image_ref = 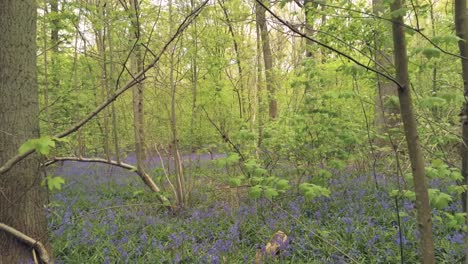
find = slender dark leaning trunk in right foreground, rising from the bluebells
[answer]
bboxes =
[392,0,436,264]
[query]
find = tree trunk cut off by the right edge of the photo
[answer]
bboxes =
[455,0,468,263]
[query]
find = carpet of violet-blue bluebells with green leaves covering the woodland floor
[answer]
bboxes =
[48,154,464,263]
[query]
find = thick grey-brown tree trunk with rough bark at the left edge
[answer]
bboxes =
[0,0,48,263]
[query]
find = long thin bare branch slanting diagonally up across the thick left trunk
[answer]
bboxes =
[0,0,209,175]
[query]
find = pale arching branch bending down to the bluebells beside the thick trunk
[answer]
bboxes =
[43,157,170,207]
